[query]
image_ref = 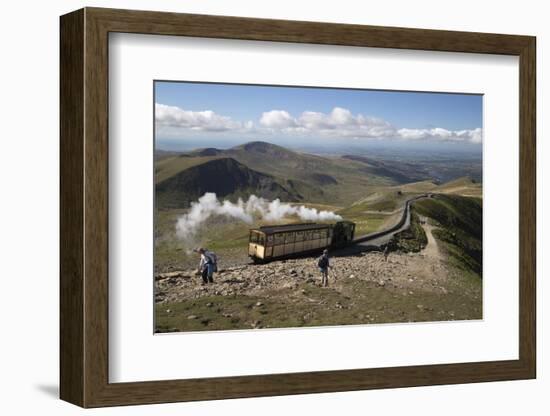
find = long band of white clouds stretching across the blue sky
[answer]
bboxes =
[155,103,482,143]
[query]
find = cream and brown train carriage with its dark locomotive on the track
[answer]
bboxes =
[248,221,355,262]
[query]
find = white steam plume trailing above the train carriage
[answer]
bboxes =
[176,192,342,240]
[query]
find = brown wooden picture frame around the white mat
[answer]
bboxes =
[60,8,536,407]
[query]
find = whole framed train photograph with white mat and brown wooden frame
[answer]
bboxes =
[60,8,536,407]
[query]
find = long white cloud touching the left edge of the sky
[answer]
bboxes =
[155,103,251,132]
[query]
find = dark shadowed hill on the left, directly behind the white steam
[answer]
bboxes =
[156,158,302,208]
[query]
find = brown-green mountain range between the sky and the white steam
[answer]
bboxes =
[155,141,478,209]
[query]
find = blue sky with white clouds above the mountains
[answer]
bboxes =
[155,81,483,147]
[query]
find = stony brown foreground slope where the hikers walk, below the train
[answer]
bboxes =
[155,224,482,332]
